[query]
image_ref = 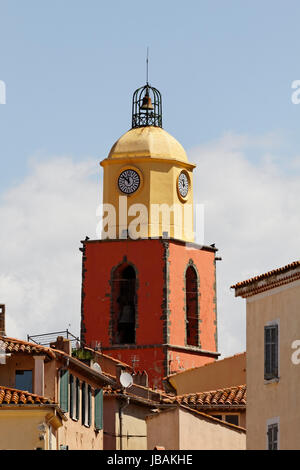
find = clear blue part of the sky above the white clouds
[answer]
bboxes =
[0,0,300,188]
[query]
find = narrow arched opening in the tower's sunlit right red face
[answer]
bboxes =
[185,266,199,346]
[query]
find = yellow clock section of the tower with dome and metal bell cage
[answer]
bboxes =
[101,84,195,241]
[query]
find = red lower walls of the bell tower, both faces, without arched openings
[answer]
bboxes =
[81,239,216,386]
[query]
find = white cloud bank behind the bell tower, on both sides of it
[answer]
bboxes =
[0,134,300,356]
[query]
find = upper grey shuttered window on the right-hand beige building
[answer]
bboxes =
[265,324,278,380]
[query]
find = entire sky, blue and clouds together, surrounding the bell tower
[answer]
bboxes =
[0,0,300,355]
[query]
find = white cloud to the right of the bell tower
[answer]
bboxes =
[190,134,300,356]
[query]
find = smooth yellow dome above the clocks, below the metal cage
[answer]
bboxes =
[108,126,188,162]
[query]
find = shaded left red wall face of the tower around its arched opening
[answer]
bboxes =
[83,240,163,347]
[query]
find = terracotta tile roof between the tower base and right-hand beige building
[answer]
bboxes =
[162,385,246,410]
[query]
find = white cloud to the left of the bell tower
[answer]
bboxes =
[0,157,100,338]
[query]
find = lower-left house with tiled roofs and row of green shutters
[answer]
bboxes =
[0,336,110,450]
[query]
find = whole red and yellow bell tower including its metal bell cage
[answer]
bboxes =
[81,83,219,387]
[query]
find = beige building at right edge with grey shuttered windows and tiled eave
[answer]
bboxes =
[232,261,300,450]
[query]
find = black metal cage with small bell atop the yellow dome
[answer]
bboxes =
[132,83,162,129]
